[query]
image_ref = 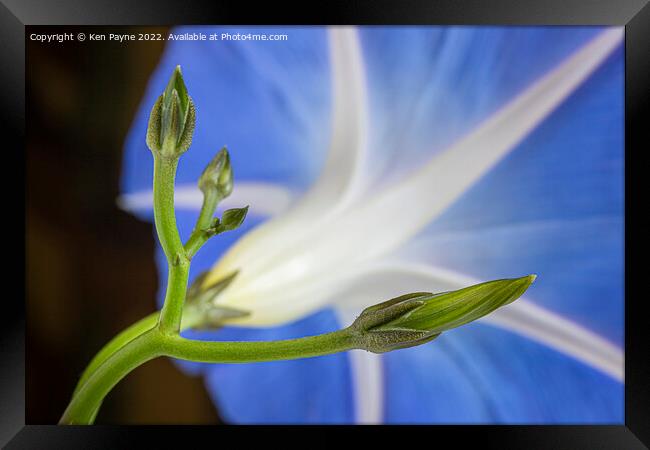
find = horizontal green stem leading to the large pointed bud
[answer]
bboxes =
[163,328,356,363]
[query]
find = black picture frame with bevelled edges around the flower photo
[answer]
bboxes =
[5,0,650,449]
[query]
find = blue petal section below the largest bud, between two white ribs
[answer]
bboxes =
[385,323,624,424]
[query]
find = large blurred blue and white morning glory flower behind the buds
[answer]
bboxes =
[119,27,623,423]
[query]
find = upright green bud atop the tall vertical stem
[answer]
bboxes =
[147,66,196,157]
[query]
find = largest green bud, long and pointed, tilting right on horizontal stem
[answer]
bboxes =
[351,275,536,353]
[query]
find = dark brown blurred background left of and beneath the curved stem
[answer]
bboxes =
[25,27,220,424]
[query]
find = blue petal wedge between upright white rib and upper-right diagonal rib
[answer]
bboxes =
[361,26,602,185]
